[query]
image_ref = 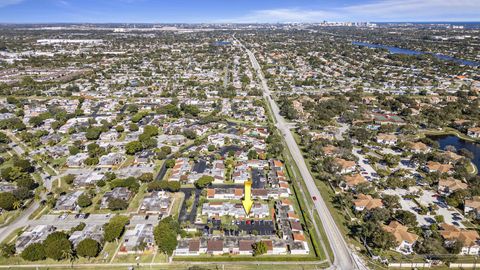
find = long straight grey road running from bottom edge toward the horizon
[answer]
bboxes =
[239,38,367,270]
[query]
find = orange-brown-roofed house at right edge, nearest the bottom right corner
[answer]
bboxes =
[440,223,480,255]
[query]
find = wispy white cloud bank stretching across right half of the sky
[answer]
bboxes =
[225,0,480,23]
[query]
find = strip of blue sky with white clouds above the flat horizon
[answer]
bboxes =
[0,0,480,23]
